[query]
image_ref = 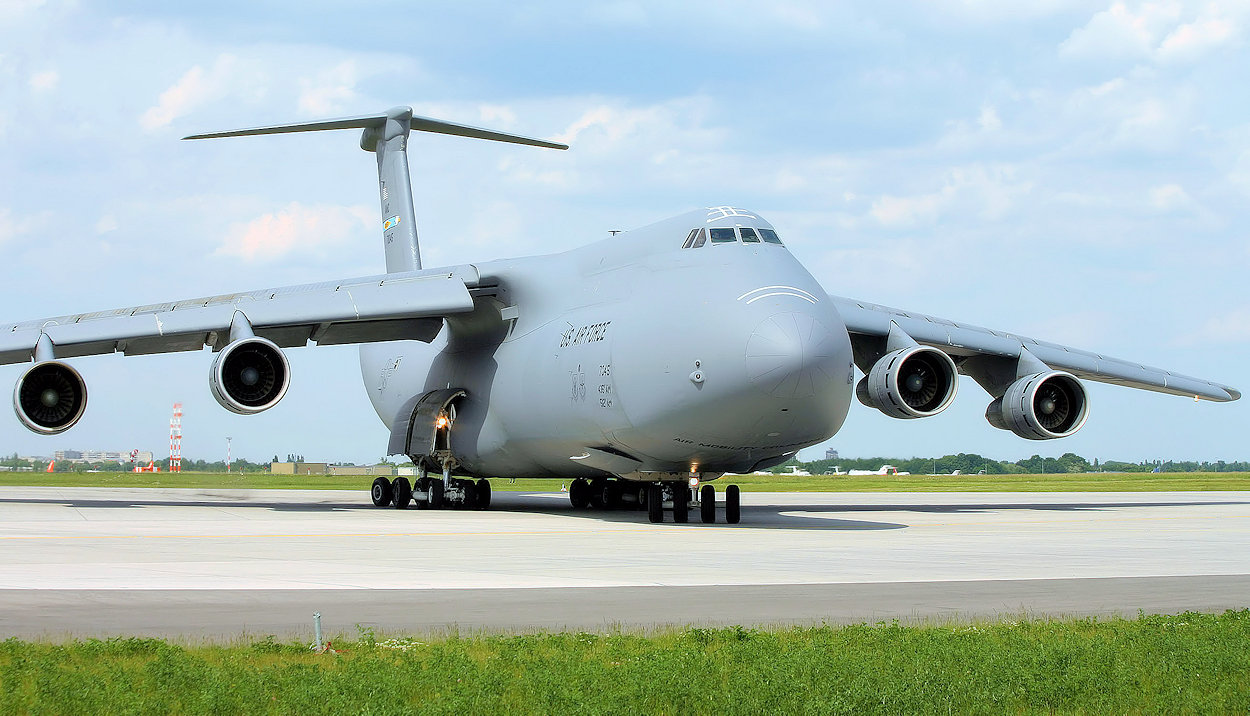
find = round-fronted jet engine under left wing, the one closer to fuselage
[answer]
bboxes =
[209,336,291,415]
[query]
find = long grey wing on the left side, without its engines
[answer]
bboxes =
[0,266,478,364]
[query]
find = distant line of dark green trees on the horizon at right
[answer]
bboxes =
[771,452,1250,475]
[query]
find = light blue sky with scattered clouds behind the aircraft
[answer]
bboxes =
[0,0,1250,461]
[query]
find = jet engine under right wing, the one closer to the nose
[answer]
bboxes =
[855,346,959,419]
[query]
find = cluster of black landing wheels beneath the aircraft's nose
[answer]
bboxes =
[569,477,743,525]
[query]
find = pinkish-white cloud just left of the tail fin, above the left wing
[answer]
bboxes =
[215,201,370,262]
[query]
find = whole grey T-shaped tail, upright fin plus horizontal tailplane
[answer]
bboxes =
[183,107,569,274]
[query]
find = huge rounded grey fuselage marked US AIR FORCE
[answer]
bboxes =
[360,210,854,477]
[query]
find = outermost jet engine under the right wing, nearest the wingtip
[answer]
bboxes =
[985,370,1089,440]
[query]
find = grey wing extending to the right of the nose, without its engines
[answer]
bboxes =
[830,296,1241,402]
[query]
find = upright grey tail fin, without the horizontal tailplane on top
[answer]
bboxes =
[360,107,421,274]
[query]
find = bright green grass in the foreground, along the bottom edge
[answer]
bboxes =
[0,610,1250,715]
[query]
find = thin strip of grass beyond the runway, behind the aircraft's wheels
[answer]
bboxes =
[0,472,1250,492]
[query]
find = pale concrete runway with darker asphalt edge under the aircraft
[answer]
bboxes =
[0,487,1250,640]
